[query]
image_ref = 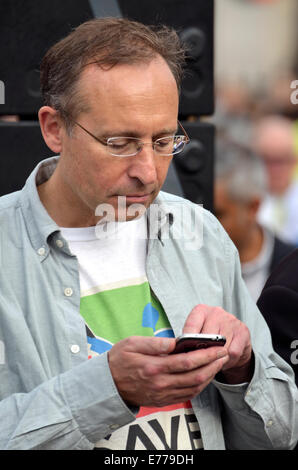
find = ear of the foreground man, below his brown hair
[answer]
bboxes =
[38,106,62,154]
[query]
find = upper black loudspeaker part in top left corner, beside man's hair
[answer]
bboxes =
[0,0,93,116]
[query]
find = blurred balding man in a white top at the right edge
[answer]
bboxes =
[254,116,298,246]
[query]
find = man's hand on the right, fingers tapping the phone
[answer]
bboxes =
[183,305,253,384]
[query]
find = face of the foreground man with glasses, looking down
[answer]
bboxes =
[58,58,178,219]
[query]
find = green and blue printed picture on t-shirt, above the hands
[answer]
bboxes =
[81,281,174,356]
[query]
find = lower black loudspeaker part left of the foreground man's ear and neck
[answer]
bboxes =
[0,121,53,196]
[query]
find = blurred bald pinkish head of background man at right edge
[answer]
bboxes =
[254,116,296,195]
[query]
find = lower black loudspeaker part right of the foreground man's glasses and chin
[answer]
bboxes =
[163,121,215,212]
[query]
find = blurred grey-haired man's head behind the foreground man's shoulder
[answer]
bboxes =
[215,141,267,251]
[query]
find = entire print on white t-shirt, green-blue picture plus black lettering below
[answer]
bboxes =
[81,279,202,450]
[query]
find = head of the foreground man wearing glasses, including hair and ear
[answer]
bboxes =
[39,18,184,224]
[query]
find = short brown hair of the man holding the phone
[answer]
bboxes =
[41,18,185,130]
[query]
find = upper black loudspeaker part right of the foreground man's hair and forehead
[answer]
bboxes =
[118,0,214,119]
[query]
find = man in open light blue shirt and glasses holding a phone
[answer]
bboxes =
[0,19,297,450]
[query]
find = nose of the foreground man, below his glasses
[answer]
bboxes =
[128,143,162,185]
